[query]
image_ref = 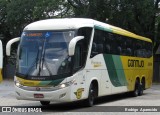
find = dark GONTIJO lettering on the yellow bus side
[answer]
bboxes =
[128,59,144,67]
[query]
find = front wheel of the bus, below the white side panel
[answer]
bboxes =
[85,84,95,107]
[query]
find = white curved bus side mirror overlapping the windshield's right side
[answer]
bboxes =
[68,36,84,56]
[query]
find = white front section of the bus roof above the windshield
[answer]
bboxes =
[24,18,94,31]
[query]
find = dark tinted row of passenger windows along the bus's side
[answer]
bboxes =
[91,29,152,58]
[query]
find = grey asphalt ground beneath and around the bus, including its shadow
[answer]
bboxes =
[0,80,160,115]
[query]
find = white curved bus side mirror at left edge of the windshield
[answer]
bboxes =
[6,37,20,56]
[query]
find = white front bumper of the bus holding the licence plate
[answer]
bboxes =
[15,85,72,102]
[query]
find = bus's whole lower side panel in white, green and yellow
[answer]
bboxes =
[86,54,153,96]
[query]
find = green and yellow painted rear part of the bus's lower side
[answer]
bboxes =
[104,54,153,91]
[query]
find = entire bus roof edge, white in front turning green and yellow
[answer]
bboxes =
[24,18,152,42]
